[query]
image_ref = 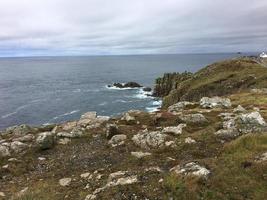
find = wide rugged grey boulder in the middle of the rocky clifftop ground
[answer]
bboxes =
[132,130,167,149]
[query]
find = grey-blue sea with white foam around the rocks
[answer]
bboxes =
[0,54,237,129]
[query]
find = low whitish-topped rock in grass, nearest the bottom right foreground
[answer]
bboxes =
[170,162,210,178]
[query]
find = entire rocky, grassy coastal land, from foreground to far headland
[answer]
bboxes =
[0,58,267,200]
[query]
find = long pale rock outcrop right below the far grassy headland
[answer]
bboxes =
[200,97,232,108]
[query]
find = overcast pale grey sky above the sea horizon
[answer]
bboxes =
[0,0,267,57]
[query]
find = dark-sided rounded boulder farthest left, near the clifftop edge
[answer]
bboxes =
[36,132,55,149]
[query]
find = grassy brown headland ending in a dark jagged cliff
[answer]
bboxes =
[154,58,267,108]
